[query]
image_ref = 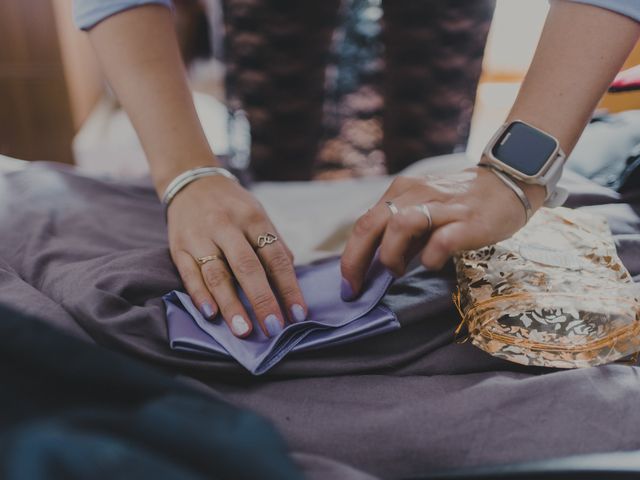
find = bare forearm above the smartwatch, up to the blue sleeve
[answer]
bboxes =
[507,0,640,154]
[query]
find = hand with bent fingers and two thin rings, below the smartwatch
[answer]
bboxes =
[341,167,544,300]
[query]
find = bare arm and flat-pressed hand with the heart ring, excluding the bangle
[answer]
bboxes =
[89,5,306,338]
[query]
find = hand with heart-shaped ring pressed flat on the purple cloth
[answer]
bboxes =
[167,176,307,338]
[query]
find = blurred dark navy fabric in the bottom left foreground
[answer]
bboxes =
[0,307,302,480]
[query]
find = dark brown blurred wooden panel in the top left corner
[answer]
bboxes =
[0,0,74,163]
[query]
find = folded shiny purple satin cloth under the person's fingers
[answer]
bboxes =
[163,259,400,375]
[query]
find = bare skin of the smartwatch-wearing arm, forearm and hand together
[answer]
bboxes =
[342,1,640,297]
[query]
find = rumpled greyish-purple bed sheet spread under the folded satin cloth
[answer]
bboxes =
[0,164,640,479]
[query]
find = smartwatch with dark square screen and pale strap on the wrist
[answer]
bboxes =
[480,120,569,207]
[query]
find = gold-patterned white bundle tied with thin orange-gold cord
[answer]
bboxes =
[454,208,640,368]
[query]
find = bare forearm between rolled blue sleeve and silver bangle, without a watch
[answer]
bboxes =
[89,5,217,193]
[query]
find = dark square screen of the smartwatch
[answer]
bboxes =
[491,122,557,176]
